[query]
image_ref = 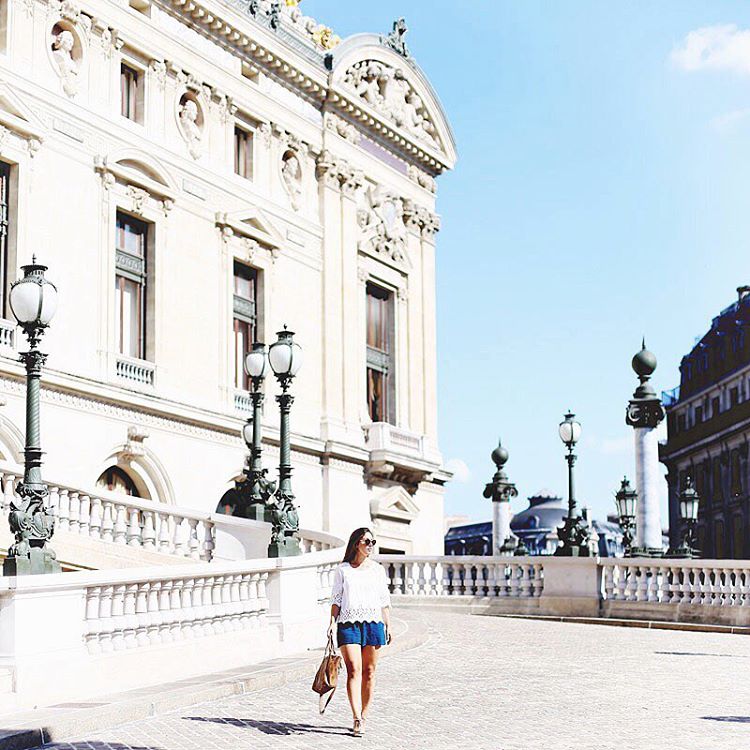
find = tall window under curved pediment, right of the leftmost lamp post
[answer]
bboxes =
[115,212,148,359]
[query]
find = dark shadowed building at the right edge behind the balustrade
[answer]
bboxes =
[661,286,750,559]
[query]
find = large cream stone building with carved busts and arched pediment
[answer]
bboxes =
[0,0,456,554]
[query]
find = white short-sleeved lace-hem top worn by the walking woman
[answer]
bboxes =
[331,560,391,622]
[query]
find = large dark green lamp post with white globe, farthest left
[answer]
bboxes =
[3,256,61,576]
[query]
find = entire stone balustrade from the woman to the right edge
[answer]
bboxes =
[378,555,750,627]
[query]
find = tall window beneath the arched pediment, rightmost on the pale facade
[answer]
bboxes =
[367,284,396,424]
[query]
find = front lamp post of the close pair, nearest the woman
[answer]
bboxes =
[268,326,302,557]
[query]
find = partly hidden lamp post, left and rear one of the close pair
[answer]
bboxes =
[237,342,276,521]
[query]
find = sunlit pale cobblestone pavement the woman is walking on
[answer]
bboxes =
[41,610,750,750]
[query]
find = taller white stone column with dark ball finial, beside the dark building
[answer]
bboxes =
[625,341,665,556]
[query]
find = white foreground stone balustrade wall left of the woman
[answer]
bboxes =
[0,547,343,715]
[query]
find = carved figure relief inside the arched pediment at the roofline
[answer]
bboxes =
[343,60,438,146]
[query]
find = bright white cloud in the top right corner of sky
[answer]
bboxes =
[671,24,750,75]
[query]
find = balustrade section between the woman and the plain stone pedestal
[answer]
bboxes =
[378,555,546,599]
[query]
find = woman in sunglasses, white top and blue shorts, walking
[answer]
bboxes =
[328,527,392,737]
